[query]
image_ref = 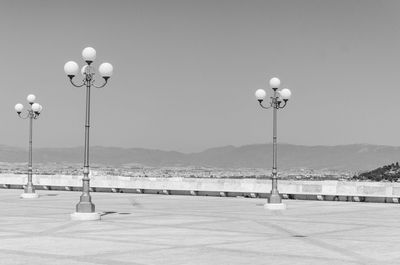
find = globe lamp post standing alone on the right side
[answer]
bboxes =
[255,77,292,210]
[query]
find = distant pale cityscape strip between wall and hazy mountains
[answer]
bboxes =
[0,162,355,180]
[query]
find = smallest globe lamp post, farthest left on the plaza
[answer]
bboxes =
[15,94,42,199]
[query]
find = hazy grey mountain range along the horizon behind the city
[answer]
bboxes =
[0,144,400,170]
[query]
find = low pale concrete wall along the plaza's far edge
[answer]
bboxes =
[0,174,400,198]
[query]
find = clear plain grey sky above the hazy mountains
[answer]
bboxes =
[0,0,400,152]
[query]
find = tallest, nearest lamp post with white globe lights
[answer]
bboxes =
[64,47,113,220]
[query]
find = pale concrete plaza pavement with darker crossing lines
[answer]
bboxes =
[0,189,400,265]
